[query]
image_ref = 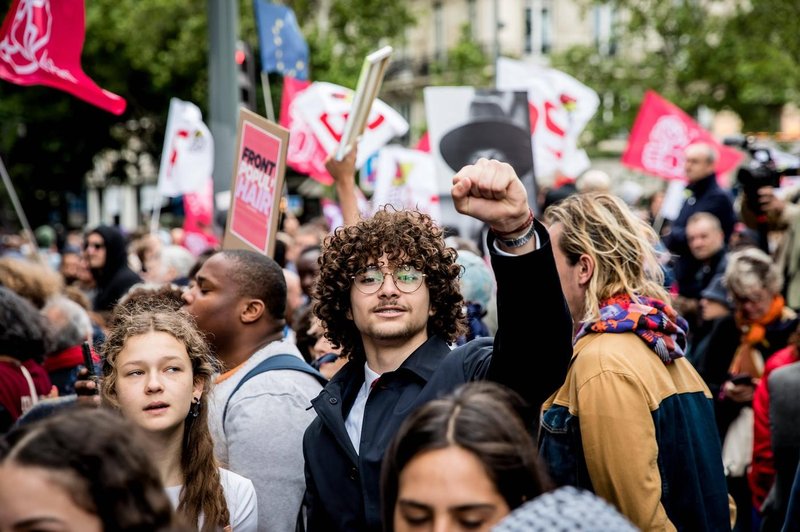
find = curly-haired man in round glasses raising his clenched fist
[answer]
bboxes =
[303,159,572,531]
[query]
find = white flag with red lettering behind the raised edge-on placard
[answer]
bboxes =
[290,81,408,168]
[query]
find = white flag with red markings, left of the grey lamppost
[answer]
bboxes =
[158,98,214,197]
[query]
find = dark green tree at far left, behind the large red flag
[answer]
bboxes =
[0,0,212,226]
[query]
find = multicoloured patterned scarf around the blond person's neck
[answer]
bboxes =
[575,294,689,364]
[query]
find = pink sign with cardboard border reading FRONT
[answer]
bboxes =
[222,108,289,256]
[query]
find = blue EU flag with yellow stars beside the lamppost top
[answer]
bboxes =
[254,0,308,79]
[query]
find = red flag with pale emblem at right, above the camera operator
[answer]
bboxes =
[622,91,742,179]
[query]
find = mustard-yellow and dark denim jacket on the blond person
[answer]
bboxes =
[539,333,730,530]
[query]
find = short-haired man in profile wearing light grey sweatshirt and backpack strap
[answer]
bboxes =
[183,250,320,532]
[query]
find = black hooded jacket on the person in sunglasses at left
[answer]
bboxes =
[89,225,142,312]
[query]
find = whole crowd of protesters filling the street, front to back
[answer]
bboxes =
[0,144,800,532]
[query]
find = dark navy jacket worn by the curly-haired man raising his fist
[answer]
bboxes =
[303,222,572,532]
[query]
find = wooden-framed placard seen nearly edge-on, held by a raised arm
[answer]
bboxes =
[336,46,393,161]
